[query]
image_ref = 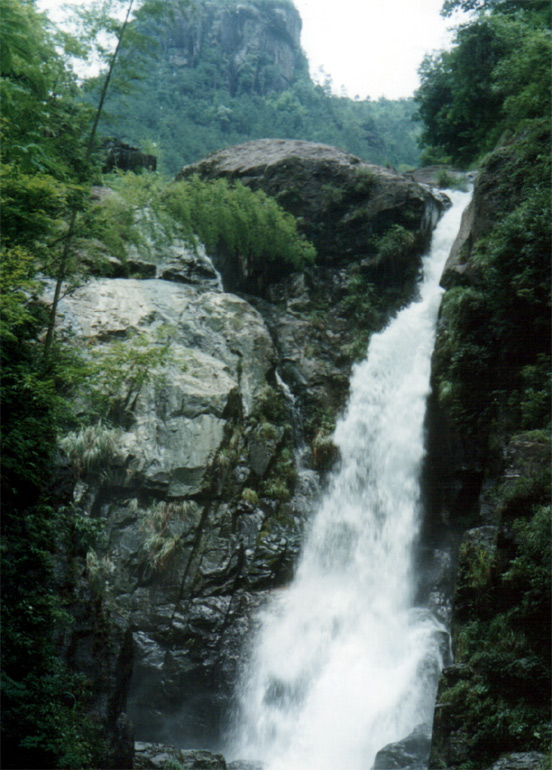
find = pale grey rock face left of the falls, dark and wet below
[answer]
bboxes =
[56,279,308,742]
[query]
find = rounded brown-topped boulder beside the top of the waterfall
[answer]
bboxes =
[177,139,442,288]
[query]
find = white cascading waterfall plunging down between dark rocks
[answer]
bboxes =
[229,192,468,770]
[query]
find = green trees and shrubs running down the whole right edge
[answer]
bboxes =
[424,12,551,752]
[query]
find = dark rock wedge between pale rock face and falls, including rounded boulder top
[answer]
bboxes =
[179,139,445,444]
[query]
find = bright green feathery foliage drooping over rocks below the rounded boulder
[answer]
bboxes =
[84,168,316,269]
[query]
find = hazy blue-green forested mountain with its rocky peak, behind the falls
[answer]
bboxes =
[91,0,419,174]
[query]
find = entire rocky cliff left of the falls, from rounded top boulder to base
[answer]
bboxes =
[49,140,443,766]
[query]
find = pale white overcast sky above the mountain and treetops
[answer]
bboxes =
[39,0,464,99]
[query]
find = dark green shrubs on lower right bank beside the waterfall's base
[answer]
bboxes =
[442,498,552,768]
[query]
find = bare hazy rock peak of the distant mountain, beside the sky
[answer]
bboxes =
[161,0,307,95]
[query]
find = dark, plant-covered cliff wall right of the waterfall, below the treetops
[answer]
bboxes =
[426,126,550,768]
